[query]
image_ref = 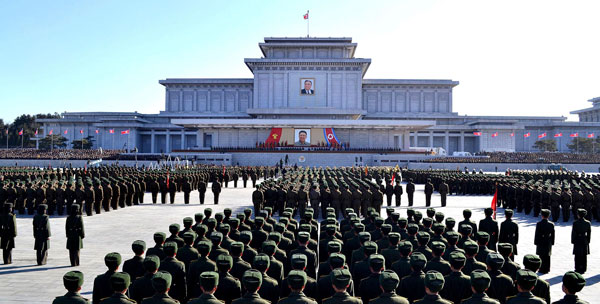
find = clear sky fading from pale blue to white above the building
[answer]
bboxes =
[0,0,600,122]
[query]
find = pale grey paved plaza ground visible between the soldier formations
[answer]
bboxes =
[0,182,600,304]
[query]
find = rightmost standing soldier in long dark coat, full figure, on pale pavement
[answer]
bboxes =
[571,208,592,274]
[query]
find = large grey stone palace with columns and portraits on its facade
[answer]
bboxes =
[38,37,600,159]
